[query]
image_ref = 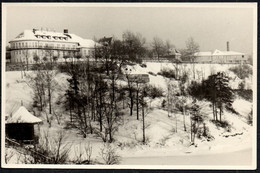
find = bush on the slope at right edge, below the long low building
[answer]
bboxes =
[229,64,253,79]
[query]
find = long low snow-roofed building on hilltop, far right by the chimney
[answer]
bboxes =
[194,49,247,63]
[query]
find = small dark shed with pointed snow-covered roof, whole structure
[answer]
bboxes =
[5,106,42,141]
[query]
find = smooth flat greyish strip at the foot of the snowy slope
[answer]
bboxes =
[121,149,252,168]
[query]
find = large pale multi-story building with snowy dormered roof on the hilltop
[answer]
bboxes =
[9,29,99,64]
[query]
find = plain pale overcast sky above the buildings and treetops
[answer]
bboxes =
[3,5,253,53]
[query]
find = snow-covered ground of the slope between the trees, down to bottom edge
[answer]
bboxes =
[5,63,254,166]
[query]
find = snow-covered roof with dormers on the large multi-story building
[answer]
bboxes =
[10,29,99,48]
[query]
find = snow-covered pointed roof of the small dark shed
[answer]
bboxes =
[6,106,42,124]
